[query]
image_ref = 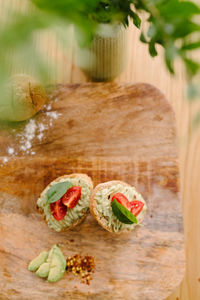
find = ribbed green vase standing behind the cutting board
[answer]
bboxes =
[76,24,127,81]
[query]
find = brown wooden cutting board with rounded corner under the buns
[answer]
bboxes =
[0,83,185,300]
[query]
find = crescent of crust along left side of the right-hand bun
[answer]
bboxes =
[90,180,145,234]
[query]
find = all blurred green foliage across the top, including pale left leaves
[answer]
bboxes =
[0,0,200,94]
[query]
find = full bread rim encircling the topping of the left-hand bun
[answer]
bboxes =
[37,173,93,232]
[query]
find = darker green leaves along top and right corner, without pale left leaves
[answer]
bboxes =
[33,0,200,77]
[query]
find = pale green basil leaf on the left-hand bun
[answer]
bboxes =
[47,181,73,203]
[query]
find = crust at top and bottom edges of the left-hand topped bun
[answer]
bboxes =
[37,173,94,232]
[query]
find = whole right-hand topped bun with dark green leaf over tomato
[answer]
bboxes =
[90,180,147,233]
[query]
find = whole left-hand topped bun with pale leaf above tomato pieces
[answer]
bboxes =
[37,174,93,231]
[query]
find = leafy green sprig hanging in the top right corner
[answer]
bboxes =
[138,0,200,77]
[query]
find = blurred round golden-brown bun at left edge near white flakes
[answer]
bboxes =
[0,74,47,122]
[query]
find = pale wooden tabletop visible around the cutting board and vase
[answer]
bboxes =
[0,0,200,300]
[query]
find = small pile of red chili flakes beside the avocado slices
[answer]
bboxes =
[66,254,95,285]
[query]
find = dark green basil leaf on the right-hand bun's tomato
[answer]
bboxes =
[111,199,137,224]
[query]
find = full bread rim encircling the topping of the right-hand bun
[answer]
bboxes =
[90,180,146,234]
